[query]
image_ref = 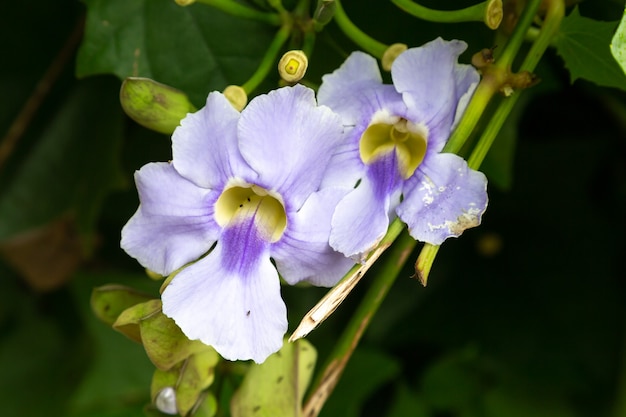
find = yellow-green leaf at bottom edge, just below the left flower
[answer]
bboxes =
[230,339,317,417]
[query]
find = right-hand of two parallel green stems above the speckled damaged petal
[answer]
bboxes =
[467,0,565,169]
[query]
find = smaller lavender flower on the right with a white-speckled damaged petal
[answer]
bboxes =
[318,38,487,259]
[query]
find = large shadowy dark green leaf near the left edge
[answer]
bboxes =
[0,79,124,243]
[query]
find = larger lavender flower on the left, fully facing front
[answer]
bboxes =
[121,86,353,362]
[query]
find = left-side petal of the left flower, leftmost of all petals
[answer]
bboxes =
[121,162,220,275]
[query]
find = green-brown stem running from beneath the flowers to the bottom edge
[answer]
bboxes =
[304,222,417,417]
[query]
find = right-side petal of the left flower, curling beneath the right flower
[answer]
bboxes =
[272,188,354,287]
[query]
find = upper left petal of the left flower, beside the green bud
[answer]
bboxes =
[172,92,256,189]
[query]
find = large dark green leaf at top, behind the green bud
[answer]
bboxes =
[76,0,275,106]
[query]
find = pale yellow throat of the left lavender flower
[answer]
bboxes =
[215,185,287,242]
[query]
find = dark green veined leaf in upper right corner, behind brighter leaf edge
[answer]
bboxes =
[554,7,626,90]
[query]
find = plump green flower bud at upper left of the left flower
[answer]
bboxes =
[120,77,196,135]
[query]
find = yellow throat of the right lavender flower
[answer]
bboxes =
[359,119,428,179]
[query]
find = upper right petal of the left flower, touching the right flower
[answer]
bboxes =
[239,85,343,210]
